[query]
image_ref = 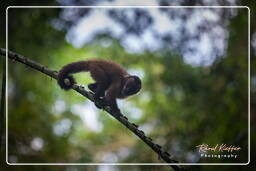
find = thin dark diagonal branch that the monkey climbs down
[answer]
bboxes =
[0,48,184,171]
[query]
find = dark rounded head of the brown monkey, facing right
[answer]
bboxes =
[121,75,141,96]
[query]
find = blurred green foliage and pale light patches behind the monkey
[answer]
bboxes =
[0,0,256,171]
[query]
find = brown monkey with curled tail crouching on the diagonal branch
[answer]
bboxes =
[58,59,141,112]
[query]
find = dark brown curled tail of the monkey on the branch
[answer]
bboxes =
[58,61,89,90]
